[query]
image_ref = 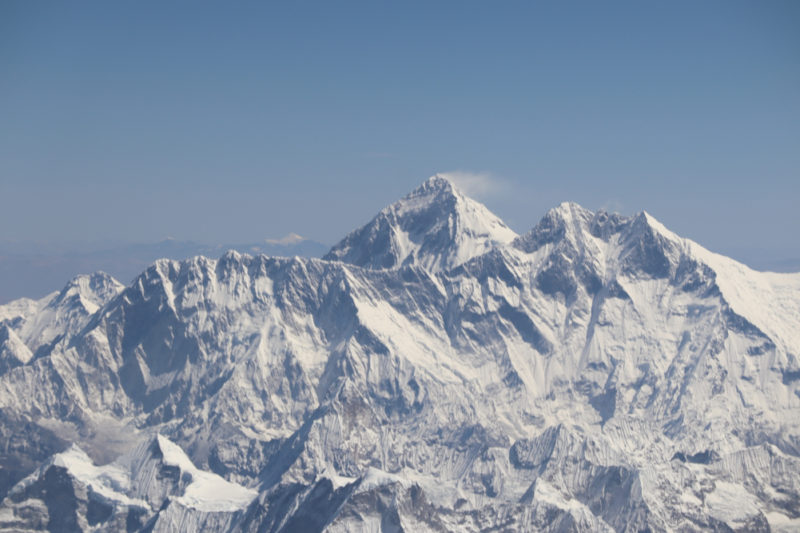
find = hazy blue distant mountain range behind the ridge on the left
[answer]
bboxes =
[0,237,329,304]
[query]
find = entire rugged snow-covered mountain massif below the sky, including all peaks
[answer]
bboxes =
[0,177,800,531]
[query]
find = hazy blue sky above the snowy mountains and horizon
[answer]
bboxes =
[0,0,800,266]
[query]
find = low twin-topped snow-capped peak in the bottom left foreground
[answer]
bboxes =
[0,435,258,531]
